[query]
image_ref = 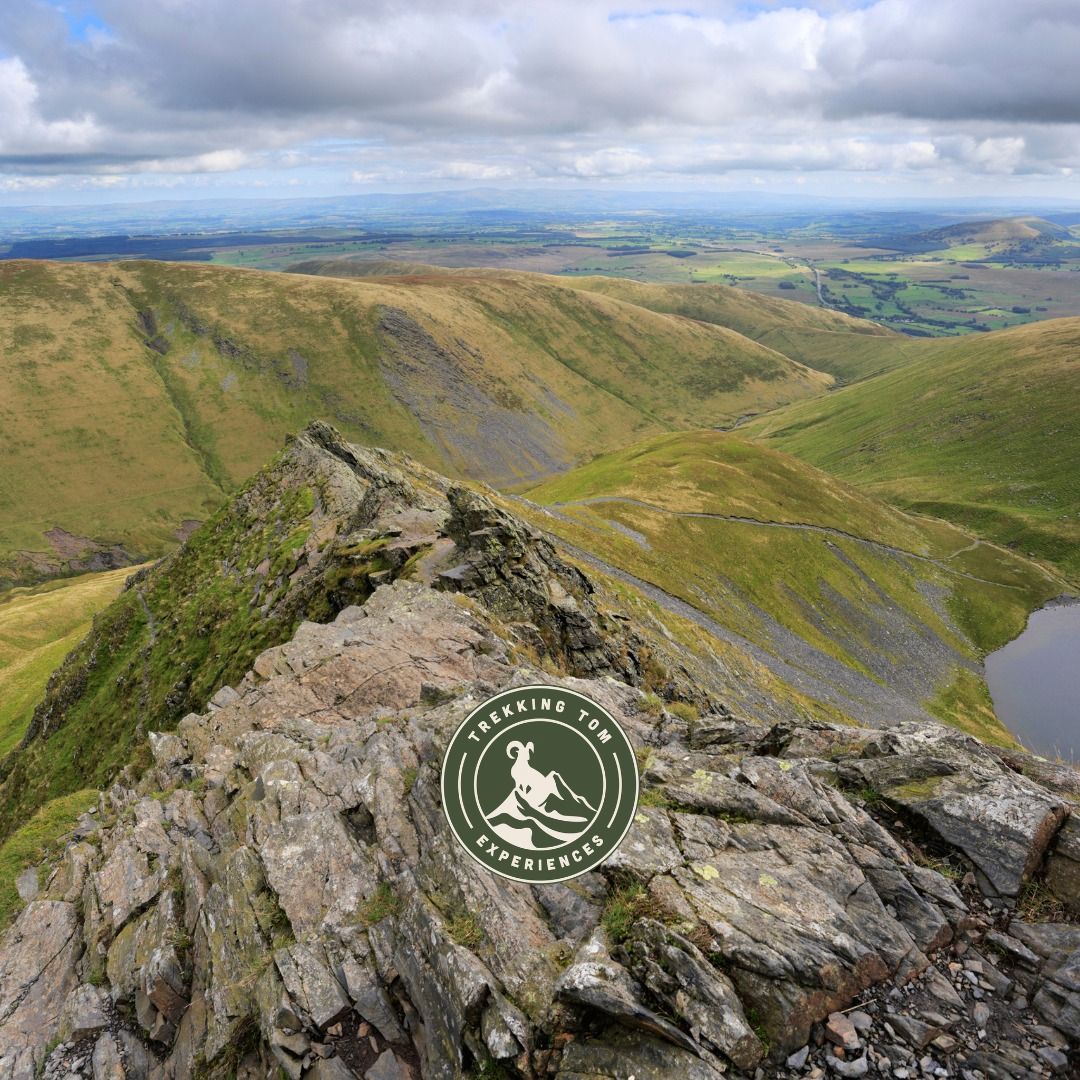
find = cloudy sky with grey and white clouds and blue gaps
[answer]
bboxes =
[0,0,1080,205]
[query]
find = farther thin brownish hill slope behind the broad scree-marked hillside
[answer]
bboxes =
[291,258,910,382]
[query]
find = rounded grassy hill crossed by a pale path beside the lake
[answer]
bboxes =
[528,432,1061,741]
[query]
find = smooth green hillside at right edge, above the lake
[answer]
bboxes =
[745,319,1080,580]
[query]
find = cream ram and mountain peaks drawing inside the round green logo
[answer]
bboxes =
[484,741,597,851]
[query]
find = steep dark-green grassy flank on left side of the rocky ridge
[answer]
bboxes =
[0,464,324,835]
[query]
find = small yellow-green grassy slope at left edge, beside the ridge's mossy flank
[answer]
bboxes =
[0,569,133,755]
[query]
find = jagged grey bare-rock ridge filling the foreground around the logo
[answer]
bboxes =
[0,428,1080,1080]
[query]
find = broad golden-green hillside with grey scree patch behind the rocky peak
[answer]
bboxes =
[0,262,829,582]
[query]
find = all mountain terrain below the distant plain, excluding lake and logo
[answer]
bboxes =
[0,261,1080,1080]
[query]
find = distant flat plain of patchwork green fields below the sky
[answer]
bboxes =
[8,205,1080,337]
